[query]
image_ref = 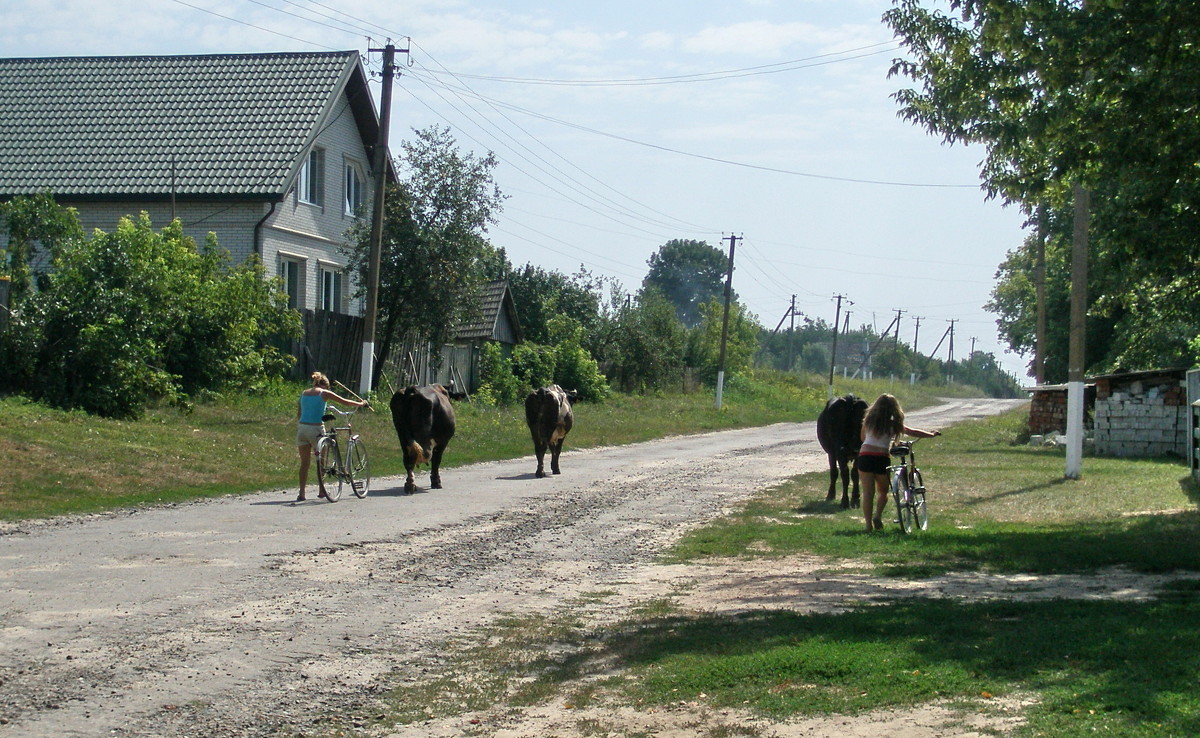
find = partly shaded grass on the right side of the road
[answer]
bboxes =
[355,414,1200,737]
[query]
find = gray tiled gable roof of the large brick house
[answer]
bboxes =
[0,52,378,198]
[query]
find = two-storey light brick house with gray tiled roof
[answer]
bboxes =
[0,50,395,314]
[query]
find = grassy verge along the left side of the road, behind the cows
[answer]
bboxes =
[0,373,973,521]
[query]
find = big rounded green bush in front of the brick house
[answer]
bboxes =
[12,214,300,418]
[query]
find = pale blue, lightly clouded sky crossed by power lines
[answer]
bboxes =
[0,0,1028,382]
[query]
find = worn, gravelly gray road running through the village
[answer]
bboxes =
[0,401,1014,738]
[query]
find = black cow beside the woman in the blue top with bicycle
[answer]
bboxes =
[391,384,455,493]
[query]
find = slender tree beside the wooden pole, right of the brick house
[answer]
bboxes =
[349,126,504,385]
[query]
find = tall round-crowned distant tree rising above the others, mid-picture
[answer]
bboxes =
[642,239,728,329]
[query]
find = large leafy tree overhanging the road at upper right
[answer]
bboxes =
[884,0,1200,370]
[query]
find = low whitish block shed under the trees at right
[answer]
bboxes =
[1094,368,1190,458]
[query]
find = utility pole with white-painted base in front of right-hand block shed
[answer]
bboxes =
[1066,182,1092,479]
